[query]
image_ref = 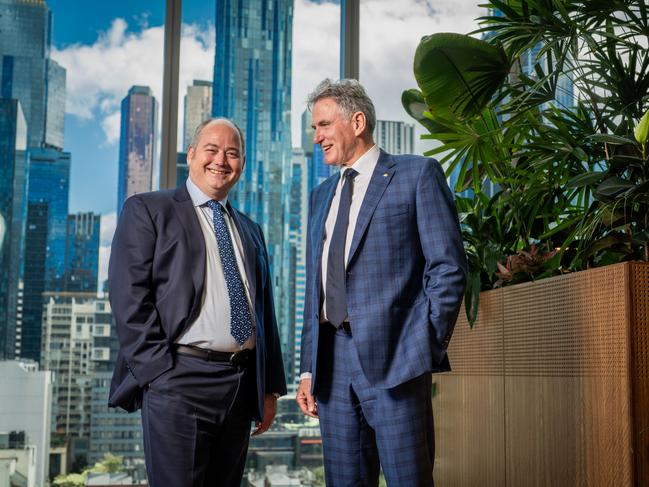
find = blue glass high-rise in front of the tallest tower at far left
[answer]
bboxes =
[16,148,70,361]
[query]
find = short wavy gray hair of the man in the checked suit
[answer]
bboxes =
[307,78,376,134]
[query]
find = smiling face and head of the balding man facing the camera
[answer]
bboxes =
[187,120,246,200]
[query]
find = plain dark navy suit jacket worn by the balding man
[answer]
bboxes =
[108,185,286,420]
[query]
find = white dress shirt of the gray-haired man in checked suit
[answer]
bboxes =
[320,145,380,322]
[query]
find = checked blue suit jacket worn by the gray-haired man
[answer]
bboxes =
[300,151,467,394]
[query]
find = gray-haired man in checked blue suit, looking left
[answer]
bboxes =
[297,80,467,487]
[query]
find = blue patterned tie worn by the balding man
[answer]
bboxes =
[207,200,252,345]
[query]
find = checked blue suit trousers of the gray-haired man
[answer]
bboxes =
[317,323,435,487]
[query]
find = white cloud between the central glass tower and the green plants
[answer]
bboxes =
[292,0,485,145]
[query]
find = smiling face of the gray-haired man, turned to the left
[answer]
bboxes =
[311,98,371,166]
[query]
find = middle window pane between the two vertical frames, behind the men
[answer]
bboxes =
[177,0,340,476]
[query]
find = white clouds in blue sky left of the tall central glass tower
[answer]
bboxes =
[52,18,214,148]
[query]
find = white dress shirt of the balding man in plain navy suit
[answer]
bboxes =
[176,178,255,352]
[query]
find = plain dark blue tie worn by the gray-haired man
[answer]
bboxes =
[325,169,358,328]
